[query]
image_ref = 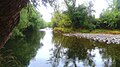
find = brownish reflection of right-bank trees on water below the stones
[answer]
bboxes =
[50,34,120,67]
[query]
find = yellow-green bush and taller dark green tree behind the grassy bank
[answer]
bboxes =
[52,0,96,30]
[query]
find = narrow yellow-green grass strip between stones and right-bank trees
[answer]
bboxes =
[54,27,120,34]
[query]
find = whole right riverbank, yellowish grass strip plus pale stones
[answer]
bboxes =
[54,28,120,44]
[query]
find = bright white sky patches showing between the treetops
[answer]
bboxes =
[38,0,108,22]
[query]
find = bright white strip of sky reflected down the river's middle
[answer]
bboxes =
[28,29,54,67]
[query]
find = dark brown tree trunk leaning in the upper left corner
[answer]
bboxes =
[0,0,28,48]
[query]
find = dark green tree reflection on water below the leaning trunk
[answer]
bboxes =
[0,31,44,67]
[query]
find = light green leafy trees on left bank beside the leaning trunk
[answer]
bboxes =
[12,4,45,37]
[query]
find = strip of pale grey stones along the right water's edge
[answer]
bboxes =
[63,33,120,44]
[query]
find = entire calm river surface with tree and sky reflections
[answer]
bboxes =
[0,29,120,67]
